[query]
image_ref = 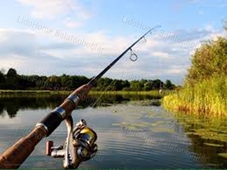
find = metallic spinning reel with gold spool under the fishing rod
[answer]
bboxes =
[46,116,98,169]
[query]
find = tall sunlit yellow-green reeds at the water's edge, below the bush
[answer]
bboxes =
[162,77,227,118]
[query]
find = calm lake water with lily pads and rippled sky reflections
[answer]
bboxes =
[0,96,227,169]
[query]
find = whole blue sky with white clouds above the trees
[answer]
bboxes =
[0,0,227,84]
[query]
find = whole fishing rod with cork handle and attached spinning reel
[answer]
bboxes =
[0,26,160,169]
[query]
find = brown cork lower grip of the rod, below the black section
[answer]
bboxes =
[0,127,47,169]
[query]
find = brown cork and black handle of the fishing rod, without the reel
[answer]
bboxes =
[0,85,92,169]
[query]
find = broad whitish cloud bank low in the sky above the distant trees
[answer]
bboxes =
[0,26,224,83]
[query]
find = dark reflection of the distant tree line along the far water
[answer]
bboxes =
[0,94,160,118]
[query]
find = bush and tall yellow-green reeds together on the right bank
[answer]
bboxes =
[163,28,227,117]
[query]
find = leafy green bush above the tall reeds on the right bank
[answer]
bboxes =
[186,37,227,85]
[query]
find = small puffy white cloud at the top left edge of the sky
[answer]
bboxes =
[17,0,92,28]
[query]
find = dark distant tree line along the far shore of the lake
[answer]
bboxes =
[0,68,176,91]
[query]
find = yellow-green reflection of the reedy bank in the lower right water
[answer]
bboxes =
[174,113,227,168]
